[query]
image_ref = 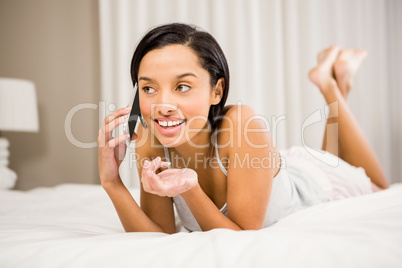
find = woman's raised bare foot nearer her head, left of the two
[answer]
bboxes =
[308,45,339,96]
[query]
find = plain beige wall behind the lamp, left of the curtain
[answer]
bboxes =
[0,0,100,190]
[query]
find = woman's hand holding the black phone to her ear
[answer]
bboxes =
[98,107,137,185]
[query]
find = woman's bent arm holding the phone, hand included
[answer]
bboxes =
[98,109,175,233]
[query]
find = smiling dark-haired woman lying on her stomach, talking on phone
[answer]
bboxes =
[98,24,388,234]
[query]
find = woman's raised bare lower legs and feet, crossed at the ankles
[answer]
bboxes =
[309,46,389,189]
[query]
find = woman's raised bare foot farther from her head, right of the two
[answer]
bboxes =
[334,49,367,99]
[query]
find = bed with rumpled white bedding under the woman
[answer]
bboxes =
[0,183,402,268]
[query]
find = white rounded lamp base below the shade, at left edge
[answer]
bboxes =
[0,137,17,189]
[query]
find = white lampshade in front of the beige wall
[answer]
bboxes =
[0,78,39,132]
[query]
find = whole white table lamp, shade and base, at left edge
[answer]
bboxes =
[0,78,39,189]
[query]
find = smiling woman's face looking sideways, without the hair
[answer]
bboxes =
[138,45,222,147]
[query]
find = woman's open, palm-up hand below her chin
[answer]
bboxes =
[141,157,198,197]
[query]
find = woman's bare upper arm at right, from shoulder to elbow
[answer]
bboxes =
[218,105,279,229]
